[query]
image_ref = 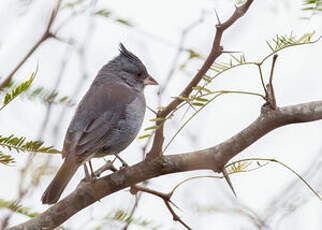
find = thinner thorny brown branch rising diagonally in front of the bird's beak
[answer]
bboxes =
[148,0,253,158]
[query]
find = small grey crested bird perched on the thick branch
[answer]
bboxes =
[41,43,158,204]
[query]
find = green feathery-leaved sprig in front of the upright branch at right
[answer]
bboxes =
[158,32,319,151]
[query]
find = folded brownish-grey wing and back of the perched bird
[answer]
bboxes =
[63,83,136,160]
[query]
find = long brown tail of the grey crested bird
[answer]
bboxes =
[41,158,80,204]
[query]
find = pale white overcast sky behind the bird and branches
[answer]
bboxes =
[0,0,322,230]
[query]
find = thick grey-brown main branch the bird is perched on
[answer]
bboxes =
[10,101,322,230]
